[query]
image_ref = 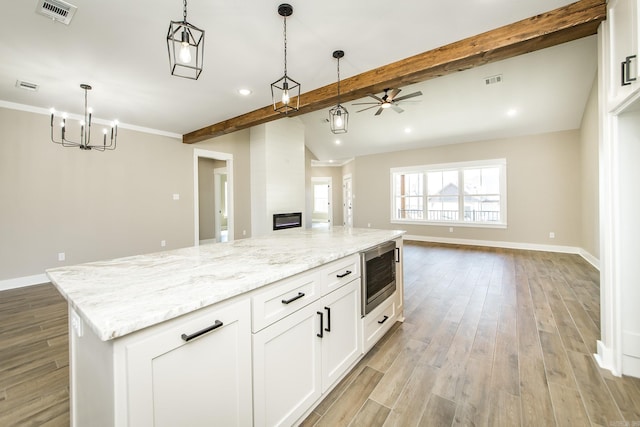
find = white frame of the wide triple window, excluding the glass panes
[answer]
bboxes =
[389,158,507,228]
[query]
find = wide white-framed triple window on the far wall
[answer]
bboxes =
[391,159,507,227]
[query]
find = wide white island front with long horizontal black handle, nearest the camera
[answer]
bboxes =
[127,301,252,427]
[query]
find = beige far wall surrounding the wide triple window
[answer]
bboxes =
[351,130,584,247]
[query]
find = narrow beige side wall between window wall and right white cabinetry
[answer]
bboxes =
[580,79,600,259]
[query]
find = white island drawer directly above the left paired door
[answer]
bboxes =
[251,271,322,332]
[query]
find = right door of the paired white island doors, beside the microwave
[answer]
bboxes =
[321,279,362,393]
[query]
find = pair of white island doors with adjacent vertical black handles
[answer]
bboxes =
[253,278,362,426]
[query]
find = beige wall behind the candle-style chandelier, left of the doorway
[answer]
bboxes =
[0,108,194,280]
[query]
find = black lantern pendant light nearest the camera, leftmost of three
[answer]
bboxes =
[167,0,204,80]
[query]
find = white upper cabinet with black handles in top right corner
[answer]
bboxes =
[607,0,640,109]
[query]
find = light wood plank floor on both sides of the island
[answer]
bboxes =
[0,242,640,427]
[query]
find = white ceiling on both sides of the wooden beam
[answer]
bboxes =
[0,0,597,161]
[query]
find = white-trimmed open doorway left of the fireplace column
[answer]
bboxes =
[193,149,234,246]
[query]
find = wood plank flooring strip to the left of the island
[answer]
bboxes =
[0,284,69,427]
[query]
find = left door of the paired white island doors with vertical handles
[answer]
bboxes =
[253,303,321,426]
